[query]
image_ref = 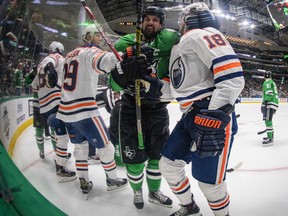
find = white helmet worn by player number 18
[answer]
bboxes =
[178,2,220,30]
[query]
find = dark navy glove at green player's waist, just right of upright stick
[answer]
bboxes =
[141,74,163,98]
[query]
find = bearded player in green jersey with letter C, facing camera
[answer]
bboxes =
[110,6,179,209]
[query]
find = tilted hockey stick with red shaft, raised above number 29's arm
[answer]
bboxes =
[80,0,122,61]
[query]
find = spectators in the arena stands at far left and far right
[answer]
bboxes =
[0,0,288,98]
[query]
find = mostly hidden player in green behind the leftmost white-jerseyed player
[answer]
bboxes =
[25,65,56,159]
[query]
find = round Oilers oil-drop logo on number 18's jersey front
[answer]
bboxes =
[170,57,185,89]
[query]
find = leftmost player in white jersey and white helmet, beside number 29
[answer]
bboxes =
[31,41,77,182]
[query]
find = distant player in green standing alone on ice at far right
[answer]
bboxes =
[261,71,279,146]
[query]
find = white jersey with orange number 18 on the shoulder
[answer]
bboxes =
[169,27,244,112]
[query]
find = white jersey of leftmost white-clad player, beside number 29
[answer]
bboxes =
[31,53,64,113]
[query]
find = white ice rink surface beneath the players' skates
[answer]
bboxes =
[13,104,288,216]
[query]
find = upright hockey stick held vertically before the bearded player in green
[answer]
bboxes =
[135,0,144,150]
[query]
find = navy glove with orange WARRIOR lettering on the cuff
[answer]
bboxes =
[192,109,230,158]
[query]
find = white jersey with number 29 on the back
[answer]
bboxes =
[57,45,118,122]
